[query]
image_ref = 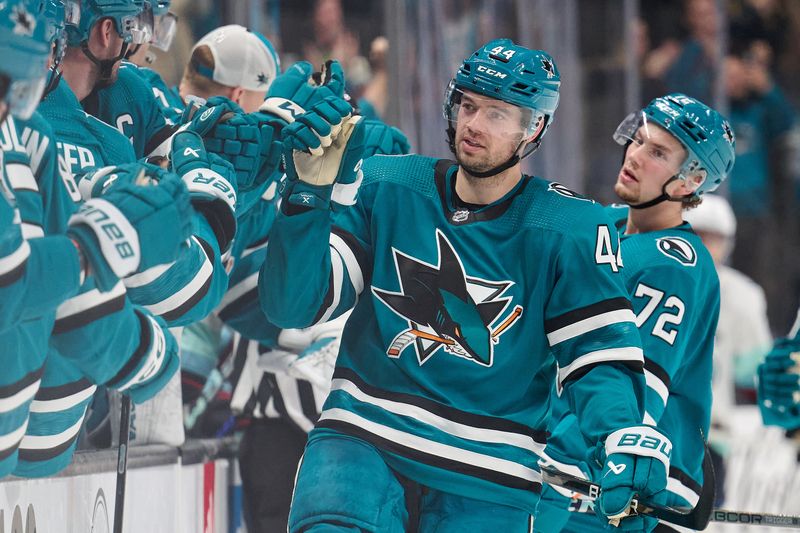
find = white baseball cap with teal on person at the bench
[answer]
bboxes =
[192,24,281,91]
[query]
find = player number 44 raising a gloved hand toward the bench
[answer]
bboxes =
[259,39,671,532]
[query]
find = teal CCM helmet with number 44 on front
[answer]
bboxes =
[444,39,561,139]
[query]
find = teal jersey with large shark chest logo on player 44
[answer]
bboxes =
[259,155,644,514]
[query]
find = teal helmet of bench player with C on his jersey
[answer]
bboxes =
[67,0,148,46]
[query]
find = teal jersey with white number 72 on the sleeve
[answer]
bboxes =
[546,206,719,506]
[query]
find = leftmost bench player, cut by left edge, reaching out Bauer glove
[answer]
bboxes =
[0,1,191,475]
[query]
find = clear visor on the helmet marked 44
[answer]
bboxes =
[444,82,546,142]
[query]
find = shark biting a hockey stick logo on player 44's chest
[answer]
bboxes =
[372,230,522,367]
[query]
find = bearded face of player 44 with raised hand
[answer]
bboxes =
[455,91,524,172]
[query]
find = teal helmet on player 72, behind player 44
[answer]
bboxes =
[614,93,736,196]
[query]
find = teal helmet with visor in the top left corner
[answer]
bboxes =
[0,0,50,119]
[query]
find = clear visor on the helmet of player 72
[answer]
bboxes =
[613,111,707,192]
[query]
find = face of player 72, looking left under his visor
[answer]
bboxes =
[614,124,686,205]
